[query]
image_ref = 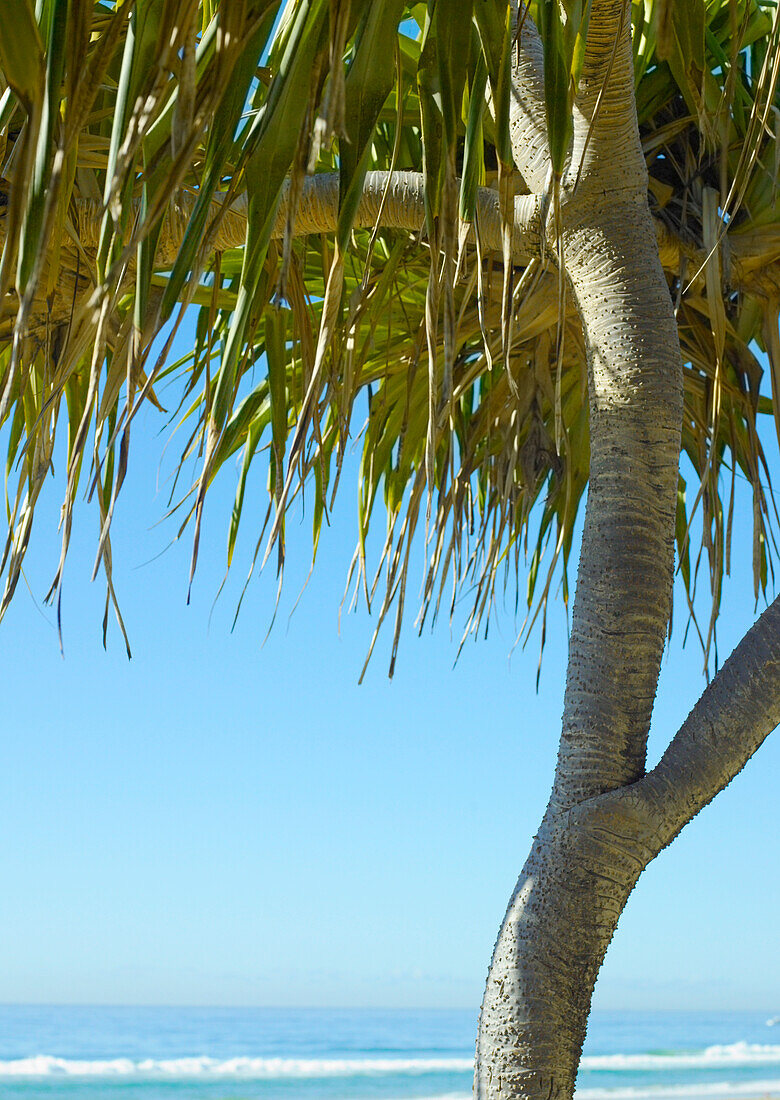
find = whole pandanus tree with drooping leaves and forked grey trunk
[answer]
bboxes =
[0,0,780,1100]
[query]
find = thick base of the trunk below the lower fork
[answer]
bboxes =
[474,811,650,1100]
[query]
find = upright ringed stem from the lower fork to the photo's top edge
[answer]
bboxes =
[513,10,682,810]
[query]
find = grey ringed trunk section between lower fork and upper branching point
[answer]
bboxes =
[553,236,682,807]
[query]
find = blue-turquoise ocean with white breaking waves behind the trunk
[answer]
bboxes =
[0,1005,780,1100]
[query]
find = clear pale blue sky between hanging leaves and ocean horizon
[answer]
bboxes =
[0,321,780,1011]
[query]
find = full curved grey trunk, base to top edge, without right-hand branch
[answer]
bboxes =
[475,0,682,1100]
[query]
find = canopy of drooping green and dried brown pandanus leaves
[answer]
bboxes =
[0,0,780,661]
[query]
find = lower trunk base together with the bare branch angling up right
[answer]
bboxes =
[474,597,780,1100]
